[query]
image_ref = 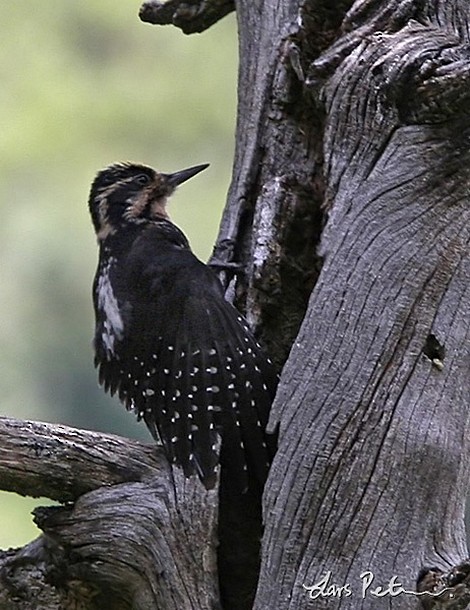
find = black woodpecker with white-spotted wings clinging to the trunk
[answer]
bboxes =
[89,163,277,490]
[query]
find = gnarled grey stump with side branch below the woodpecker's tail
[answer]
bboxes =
[0,418,218,610]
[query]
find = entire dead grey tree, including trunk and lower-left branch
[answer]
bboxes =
[0,0,470,610]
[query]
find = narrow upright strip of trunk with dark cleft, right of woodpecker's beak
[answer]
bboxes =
[211,0,324,368]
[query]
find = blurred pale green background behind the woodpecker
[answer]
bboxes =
[0,0,237,549]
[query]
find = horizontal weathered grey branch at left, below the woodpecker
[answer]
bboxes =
[0,417,170,502]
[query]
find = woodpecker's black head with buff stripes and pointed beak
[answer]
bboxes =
[88,163,208,239]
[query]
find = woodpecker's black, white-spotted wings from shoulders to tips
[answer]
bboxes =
[97,228,277,489]
